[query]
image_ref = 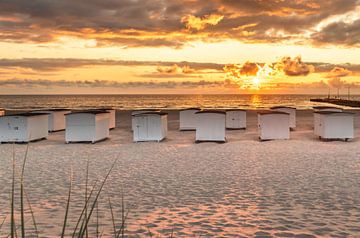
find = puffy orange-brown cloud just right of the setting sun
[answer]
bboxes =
[274,56,315,76]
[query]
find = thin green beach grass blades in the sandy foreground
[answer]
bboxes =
[5,144,124,238]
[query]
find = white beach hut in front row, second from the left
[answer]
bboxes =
[65,110,110,143]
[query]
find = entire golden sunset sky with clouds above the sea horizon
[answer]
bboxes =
[0,0,360,94]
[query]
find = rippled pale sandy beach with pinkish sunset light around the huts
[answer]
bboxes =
[0,110,360,237]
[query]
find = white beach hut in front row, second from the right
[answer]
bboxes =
[258,111,290,140]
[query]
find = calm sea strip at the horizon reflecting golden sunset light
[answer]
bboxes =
[0,94,360,110]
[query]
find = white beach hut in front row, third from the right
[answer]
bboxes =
[195,110,226,143]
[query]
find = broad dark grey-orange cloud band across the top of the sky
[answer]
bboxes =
[0,0,360,48]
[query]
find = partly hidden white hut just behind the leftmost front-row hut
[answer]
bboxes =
[32,108,71,132]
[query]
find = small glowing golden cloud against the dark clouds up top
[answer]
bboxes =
[181,14,224,31]
